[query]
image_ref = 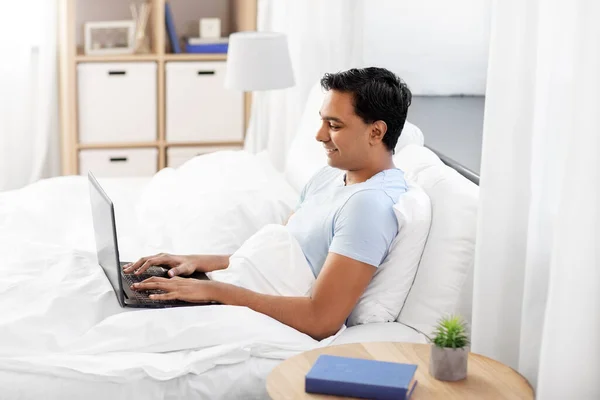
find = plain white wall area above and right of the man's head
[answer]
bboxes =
[363,0,491,95]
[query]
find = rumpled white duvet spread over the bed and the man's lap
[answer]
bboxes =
[0,152,331,382]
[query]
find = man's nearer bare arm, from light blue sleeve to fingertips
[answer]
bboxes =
[134,253,376,340]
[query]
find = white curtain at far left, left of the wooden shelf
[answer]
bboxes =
[0,0,60,191]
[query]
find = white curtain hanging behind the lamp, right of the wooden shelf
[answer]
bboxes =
[245,0,364,169]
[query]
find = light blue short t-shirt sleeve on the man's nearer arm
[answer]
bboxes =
[329,190,398,267]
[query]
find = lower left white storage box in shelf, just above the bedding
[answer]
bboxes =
[79,148,158,178]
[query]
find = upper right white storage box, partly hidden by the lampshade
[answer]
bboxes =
[166,61,244,143]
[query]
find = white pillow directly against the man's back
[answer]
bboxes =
[348,182,431,326]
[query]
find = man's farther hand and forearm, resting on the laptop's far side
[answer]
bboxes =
[123,253,229,277]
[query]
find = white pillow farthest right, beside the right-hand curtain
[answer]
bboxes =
[398,155,479,335]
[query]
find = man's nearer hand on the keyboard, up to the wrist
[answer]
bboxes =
[131,276,216,303]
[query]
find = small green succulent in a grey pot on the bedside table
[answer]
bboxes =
[429,316,469,381]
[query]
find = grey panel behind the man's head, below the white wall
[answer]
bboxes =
[407,96,485,174]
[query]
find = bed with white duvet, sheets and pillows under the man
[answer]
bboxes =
[0,83,477,399]
